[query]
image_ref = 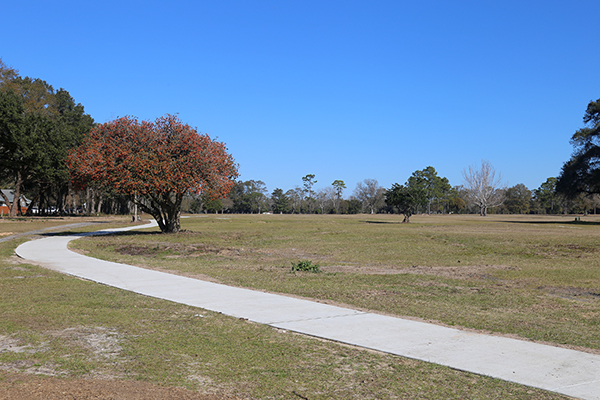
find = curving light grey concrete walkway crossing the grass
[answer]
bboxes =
[11,225,600,399]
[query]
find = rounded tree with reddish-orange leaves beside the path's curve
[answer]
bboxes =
[67,115,238,233]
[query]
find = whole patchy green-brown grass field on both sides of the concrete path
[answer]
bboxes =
[0,215,600,400]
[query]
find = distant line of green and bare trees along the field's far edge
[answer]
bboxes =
[189,167,600,222]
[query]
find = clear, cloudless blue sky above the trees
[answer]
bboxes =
[0,0,600,195]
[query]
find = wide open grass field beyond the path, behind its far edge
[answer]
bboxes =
[74,215,600,351]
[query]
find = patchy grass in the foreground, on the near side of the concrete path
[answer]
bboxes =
[0,216,564,400]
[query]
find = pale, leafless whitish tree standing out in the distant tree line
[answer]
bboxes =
[463,160,504,216]
